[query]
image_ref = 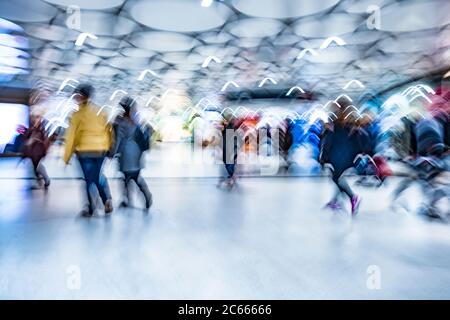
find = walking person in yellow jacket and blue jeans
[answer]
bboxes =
[63,84,113,216]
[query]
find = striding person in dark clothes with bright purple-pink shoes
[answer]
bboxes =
[319,98,364,215]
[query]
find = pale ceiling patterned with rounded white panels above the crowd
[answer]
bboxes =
[0,0,450,100]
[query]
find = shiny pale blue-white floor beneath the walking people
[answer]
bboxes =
[0,178,450,299]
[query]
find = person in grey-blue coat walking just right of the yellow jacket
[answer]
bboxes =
[113,97,153,209]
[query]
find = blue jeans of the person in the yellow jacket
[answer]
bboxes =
[78,155,111,212]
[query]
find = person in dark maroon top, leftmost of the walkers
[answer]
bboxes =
[21,115,52,190]
